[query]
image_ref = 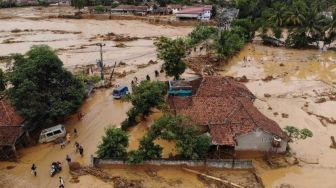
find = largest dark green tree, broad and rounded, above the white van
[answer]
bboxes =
[6,45,85,125]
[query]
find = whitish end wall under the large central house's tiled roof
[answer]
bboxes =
[235,129,287,153]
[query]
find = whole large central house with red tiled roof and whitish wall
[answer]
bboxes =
[168,76,288,153]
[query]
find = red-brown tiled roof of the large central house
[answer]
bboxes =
[169,77,287,146]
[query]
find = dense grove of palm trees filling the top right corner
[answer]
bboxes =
[236,0,336,48]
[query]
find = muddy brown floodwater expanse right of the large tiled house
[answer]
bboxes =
[220,44,336,188]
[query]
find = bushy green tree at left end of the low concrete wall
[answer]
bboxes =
[96,128,128,158]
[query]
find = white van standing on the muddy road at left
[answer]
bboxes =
[39,124,66,143]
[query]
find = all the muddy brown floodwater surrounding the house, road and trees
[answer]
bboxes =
[0,5,336,188]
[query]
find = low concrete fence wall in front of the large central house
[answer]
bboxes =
[91,157,254,169]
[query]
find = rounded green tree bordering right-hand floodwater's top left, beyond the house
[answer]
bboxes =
[212,31,245,59]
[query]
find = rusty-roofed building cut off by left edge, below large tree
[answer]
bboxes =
[0,96,27,159]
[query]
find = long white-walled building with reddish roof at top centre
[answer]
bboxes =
[175,5,212,20]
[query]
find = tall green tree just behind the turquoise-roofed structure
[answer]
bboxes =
[154,37,187,80]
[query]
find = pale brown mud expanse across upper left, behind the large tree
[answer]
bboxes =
[0,13,192,71]
